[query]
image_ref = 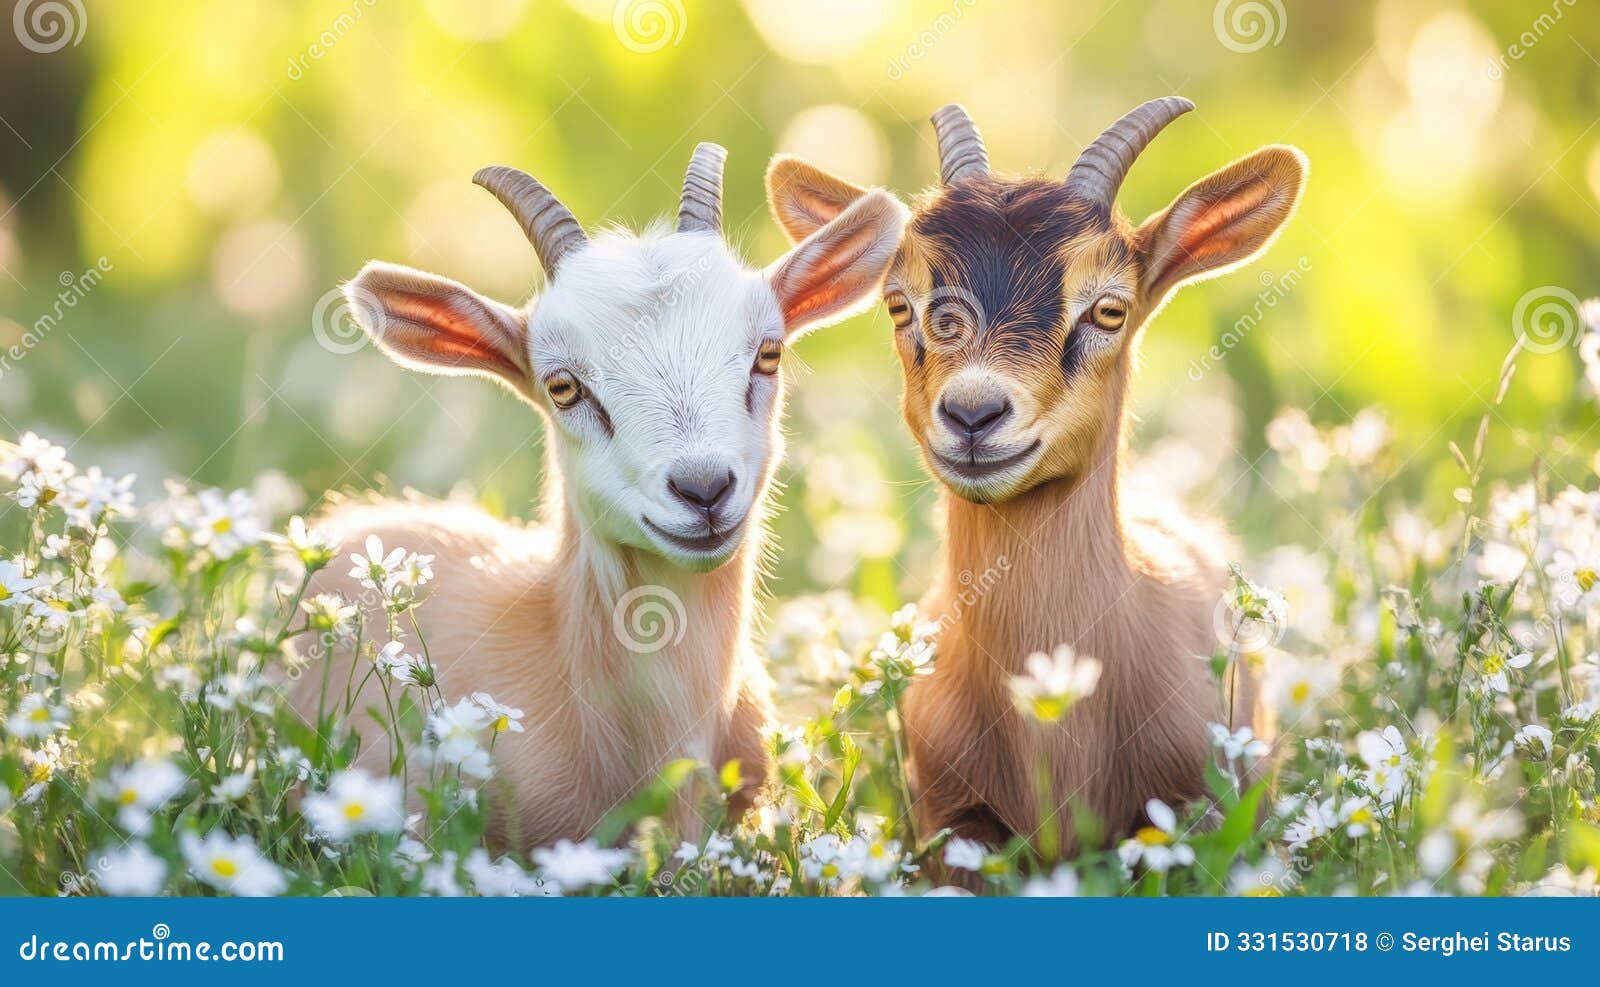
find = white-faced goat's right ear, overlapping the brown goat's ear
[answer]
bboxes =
[766,189,906,336]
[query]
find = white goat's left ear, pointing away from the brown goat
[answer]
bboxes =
[344,261,533,397]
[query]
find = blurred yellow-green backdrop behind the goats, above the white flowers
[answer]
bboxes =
[0,0,1600,605]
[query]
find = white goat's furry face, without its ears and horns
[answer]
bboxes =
[530,234,786,568]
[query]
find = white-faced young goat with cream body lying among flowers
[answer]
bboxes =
[296,144,906,846]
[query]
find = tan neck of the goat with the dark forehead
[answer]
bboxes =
[926,406,1136,673]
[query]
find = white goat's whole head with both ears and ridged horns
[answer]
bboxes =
[347,146,906,569]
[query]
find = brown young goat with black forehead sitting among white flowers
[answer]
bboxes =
[768,98,1306,851]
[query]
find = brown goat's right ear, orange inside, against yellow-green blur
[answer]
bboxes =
[1136,146,1307,301]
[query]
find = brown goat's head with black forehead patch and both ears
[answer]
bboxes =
[768,101,1304,502]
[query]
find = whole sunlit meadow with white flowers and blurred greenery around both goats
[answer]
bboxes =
[0,0,1600,896]
